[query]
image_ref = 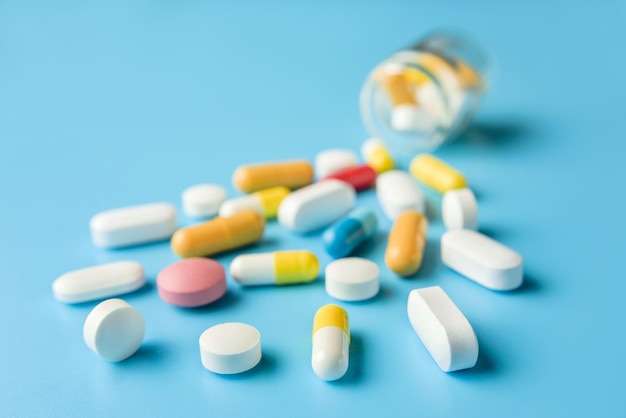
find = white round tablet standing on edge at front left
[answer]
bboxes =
[83,299,146,361]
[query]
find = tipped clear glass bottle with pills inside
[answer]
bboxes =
[360,32,488,155]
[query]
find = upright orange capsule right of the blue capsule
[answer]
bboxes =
[385,210,428,276]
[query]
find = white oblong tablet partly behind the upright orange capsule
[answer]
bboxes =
[376,170,424,220]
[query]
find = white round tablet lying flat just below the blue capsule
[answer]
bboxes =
[325,257,380,302]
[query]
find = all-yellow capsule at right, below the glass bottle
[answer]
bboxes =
[409,154,467,193]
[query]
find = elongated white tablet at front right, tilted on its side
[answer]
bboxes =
[407,286,478,372]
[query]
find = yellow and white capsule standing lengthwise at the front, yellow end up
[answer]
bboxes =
[311,305,350,381]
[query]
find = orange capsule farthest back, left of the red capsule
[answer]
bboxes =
[233,160,314,193]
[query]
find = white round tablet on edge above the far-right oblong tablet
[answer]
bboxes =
[441,188,478,230]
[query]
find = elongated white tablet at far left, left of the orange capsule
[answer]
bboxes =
[89,203,176,248]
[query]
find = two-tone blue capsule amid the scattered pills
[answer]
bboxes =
[322,208,378,258]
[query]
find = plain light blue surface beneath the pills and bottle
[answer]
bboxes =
[0,1,626,417]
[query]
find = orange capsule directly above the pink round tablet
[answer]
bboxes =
[172,210,265,258]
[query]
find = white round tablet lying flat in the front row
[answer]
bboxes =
[200,322,261,374]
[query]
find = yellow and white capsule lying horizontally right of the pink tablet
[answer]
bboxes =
[230,250,320,286]
